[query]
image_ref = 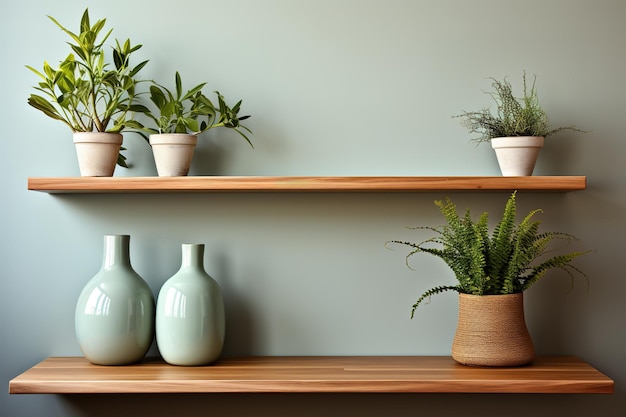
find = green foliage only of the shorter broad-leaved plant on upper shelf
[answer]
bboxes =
[136,72,253,146]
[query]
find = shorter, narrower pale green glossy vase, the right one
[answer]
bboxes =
[156,244,226,366]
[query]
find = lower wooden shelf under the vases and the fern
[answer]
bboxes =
[9,356,614,394]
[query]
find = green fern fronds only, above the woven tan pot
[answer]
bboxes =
[387,192,589,318]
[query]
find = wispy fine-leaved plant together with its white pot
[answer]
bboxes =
[454,72,581,176]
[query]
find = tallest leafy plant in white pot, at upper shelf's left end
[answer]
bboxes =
[27,10,148,176]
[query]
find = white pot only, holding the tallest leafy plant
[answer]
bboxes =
[74,132,123,177]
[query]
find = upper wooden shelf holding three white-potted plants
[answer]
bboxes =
[28,176,587,194]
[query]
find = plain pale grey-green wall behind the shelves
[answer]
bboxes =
[0,0,626,417]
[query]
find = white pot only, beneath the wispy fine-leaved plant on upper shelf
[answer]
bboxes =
[491,136,544,177]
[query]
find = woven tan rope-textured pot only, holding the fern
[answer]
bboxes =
[452,293,535,366]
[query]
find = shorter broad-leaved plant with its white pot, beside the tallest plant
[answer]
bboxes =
[136,72,254,177]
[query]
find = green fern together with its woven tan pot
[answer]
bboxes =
[388,192,588,366]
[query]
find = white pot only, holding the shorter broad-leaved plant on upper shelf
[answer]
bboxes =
[150,133,198,177]
